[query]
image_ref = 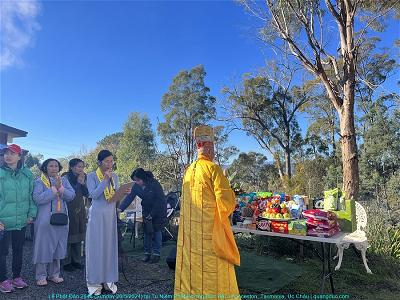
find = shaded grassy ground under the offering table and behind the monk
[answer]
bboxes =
[119,227,400,300]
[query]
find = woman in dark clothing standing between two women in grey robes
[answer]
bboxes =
[63,158,89,271]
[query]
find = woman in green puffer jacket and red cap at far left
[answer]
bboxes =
[0,144,37,293]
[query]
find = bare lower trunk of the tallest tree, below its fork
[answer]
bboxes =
[339,84,359,200]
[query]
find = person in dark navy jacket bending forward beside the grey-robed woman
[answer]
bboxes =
[119,168,167,263]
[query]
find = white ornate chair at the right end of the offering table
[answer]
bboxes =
[334,201,372,274]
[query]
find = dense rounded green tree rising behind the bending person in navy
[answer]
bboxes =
[117,112,156,182]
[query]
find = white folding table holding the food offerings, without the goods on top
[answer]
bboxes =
[232,226,347,294]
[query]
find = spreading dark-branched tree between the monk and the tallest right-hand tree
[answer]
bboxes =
[224,75,309,178]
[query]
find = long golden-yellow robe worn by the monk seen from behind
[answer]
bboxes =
[174,156,240,299]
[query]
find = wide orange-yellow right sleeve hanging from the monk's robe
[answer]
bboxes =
[212,165,240,266]
